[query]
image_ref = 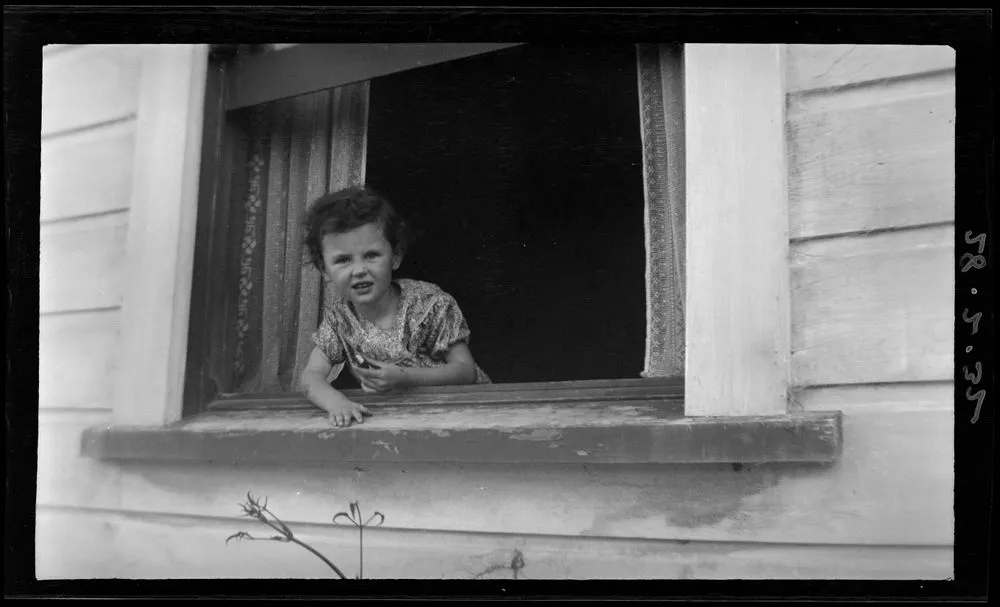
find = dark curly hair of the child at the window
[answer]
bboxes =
[302,187,413,272]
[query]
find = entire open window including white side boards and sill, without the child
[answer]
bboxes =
[82,44,841,465]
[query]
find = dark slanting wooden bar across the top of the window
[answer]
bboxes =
[226,43,518,110]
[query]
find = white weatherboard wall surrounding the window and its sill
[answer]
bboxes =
[36,46,954,579]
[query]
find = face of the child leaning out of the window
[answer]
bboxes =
[323,223,402,307]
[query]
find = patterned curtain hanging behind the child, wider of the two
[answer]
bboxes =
[228,82,368,394]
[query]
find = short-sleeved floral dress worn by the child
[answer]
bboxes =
[312,278,490,384]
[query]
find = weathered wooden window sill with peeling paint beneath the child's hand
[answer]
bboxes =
[82,381,842,464]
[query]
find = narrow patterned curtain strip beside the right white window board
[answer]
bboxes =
[637,44,686,377]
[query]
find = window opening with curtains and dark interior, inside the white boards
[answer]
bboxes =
[185,44,684,414]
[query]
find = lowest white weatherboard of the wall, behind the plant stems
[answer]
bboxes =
[36,511,954,581]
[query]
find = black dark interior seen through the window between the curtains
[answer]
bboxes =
[338,45,645,387]
